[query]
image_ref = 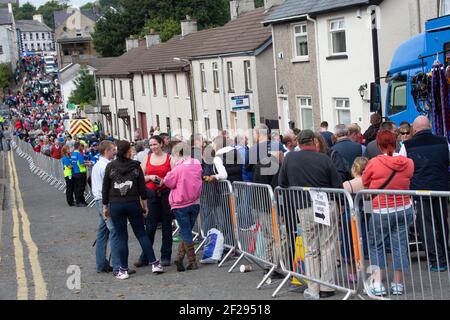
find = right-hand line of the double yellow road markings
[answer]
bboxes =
[11,152,47,300]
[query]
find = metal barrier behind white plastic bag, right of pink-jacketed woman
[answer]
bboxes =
[196,180,237,267]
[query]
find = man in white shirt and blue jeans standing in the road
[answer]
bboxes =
[91,140,120,273]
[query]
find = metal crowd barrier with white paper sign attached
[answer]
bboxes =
[272,187,360,299]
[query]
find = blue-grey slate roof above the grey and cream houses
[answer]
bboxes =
[264,0,383,24]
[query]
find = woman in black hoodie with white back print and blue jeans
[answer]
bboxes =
[102,141,164,280]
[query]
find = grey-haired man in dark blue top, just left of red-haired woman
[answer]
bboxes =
[331,124,363,181]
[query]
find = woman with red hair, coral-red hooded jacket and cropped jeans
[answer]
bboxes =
[362,130,414,296]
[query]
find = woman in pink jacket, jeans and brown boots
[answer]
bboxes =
[164,143,202,271]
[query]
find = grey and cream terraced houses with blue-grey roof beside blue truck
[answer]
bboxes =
[264,0,445,130]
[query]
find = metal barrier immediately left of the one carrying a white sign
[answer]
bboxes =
[228,182,279,289]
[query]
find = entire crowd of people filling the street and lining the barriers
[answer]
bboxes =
[4,57,450,299]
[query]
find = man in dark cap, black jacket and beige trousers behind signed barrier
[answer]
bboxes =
[279,130,342,299]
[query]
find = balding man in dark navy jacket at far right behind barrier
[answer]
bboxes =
[400,116,450,271]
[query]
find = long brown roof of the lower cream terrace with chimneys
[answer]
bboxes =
[97,8,272,76]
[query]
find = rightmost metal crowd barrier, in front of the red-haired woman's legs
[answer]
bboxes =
[355,190,450,300]
